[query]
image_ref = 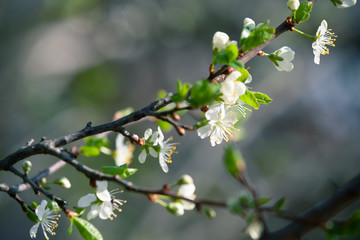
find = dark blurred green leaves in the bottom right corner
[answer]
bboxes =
[326,210,360,240]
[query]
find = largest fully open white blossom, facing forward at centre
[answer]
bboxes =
[197,103,237,147]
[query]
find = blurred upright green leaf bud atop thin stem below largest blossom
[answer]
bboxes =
[224,145,245,178]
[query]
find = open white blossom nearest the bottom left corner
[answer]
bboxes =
[30,200,60,239]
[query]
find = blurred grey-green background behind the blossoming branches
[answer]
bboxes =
[0,0,360,240]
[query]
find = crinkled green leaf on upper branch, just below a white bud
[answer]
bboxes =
[240,20,275,52]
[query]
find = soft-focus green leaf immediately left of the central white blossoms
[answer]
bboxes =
[188,79,220,107]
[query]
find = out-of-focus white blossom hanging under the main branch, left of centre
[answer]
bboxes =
[115,134,134,166]
